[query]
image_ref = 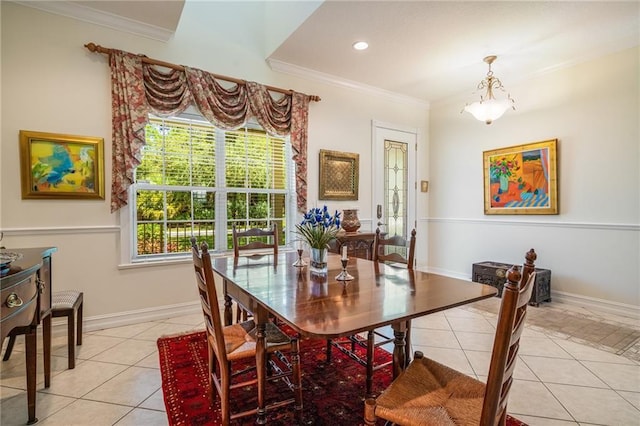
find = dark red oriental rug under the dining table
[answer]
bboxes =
[158,331,526,426]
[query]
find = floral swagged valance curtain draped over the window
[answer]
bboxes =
[109,49,310,212]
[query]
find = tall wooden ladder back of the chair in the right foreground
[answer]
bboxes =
[480,249,537,425]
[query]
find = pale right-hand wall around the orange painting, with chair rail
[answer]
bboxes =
[424,48,640,312]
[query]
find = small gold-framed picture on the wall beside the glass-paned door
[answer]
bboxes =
[319,149,360,200]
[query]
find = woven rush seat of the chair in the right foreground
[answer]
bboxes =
[376,358,485,426]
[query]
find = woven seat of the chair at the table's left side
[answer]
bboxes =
[224,320,291,361]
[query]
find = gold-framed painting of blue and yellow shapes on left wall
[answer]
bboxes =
[20,130,104,199]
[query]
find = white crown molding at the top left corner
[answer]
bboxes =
[14,1,174,42]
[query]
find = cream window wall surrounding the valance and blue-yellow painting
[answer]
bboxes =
[0,2,428,324]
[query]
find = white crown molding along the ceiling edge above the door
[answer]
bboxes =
[267,58,429,110]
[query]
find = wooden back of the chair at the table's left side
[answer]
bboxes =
[191,237,227,365]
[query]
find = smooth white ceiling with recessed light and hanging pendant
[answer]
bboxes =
[20,0,640,102]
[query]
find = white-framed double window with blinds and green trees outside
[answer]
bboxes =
[129,113,295,260]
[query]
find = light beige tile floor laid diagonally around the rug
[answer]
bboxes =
[0,299,640,426]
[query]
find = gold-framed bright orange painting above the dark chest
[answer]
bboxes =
[483,139,558,215]
